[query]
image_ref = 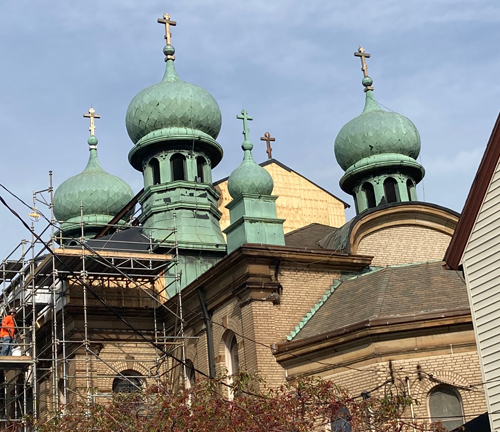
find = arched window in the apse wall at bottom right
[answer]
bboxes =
[429,384,464,431]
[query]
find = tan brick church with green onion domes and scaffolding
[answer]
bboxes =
[0,14,492,431]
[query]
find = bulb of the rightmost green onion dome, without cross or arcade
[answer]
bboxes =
[334,90,420,171]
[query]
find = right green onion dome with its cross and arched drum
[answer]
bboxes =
[334,47,425,213]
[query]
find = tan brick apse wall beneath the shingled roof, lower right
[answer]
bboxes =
[324,349,486,422]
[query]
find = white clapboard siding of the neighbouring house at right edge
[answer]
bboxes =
[462,157,500,431]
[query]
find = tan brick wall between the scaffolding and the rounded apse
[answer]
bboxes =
[182,265,339,385]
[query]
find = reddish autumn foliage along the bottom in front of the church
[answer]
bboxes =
[33,373,450,432]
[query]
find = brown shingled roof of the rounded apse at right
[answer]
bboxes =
[293,262,469,340]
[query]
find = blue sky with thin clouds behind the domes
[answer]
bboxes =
[0,0,500,256]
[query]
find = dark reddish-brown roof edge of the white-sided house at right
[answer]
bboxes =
[444,114,500,270]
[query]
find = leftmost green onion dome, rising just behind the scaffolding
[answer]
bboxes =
[54,136,134,224]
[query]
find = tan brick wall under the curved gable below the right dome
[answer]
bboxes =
[357,226,451,267]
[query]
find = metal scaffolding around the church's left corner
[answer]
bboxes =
[0,173,187,431]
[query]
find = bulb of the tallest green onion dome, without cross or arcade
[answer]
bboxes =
[126,45,222,148]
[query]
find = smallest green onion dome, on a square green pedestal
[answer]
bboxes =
[227,140,274,199]
